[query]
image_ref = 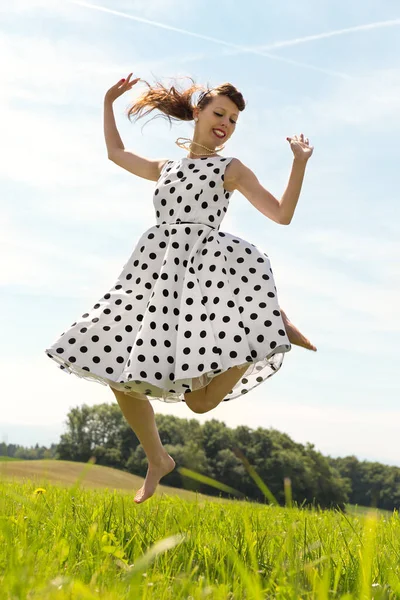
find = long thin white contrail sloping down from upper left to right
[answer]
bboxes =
[67,0,352,79]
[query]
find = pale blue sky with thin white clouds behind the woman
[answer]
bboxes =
[0,0,400,466]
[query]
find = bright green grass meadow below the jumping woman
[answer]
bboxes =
[0,461,400,600]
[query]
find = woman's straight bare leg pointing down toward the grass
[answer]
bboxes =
[110,386,175,504]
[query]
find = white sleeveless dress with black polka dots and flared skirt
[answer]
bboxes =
[45,156,291,402]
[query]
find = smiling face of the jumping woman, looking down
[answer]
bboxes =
[194,95,239,148]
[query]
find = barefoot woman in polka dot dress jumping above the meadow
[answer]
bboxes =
[46,73,316,503]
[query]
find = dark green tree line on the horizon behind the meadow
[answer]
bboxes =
[0,403,400,510]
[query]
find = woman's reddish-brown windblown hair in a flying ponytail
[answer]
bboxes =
[127,77,246,126]
